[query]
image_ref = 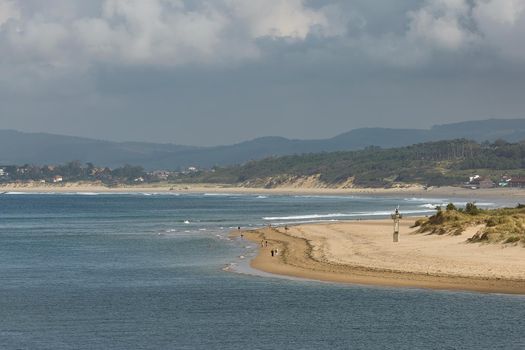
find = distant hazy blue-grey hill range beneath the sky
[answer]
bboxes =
[0,119,525,170]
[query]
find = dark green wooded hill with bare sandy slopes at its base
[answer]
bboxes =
[178,139,525,187]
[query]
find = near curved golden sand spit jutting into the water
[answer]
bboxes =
[239,219,525,294]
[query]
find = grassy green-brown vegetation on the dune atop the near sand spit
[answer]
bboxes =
[415,203,525,246]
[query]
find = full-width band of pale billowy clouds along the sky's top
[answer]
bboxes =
[0,0,525,66]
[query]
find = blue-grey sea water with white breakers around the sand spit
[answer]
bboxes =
[0,193,525,350]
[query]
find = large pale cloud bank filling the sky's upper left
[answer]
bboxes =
[0,0,346,67]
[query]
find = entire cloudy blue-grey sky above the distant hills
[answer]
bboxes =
[0,0,525,146]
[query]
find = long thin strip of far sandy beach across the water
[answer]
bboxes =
[0,182,525,201]
